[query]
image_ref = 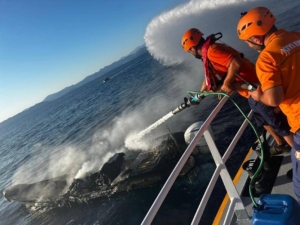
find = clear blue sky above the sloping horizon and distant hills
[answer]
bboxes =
[0,0,189,122]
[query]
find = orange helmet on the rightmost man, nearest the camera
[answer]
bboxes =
[237,7,276,41]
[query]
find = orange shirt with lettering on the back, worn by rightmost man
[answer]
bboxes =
[256,29,300,133]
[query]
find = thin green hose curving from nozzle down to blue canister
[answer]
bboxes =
[187,91,264,207]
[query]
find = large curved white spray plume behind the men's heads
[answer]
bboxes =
[144,0,253,67]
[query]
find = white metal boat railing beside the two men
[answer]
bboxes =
[141,97,253,225]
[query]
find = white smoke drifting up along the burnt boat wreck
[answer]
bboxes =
[12,92,175,189]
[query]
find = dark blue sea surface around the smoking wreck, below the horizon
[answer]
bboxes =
[0,50,251,224]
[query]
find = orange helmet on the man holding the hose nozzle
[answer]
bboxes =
[181,28,203,52]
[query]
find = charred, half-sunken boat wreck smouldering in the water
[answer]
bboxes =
[3,133,202,212]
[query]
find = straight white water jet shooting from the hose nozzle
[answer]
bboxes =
[125,112,174,149]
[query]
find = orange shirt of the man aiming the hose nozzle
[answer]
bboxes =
[207,43,258,98]
